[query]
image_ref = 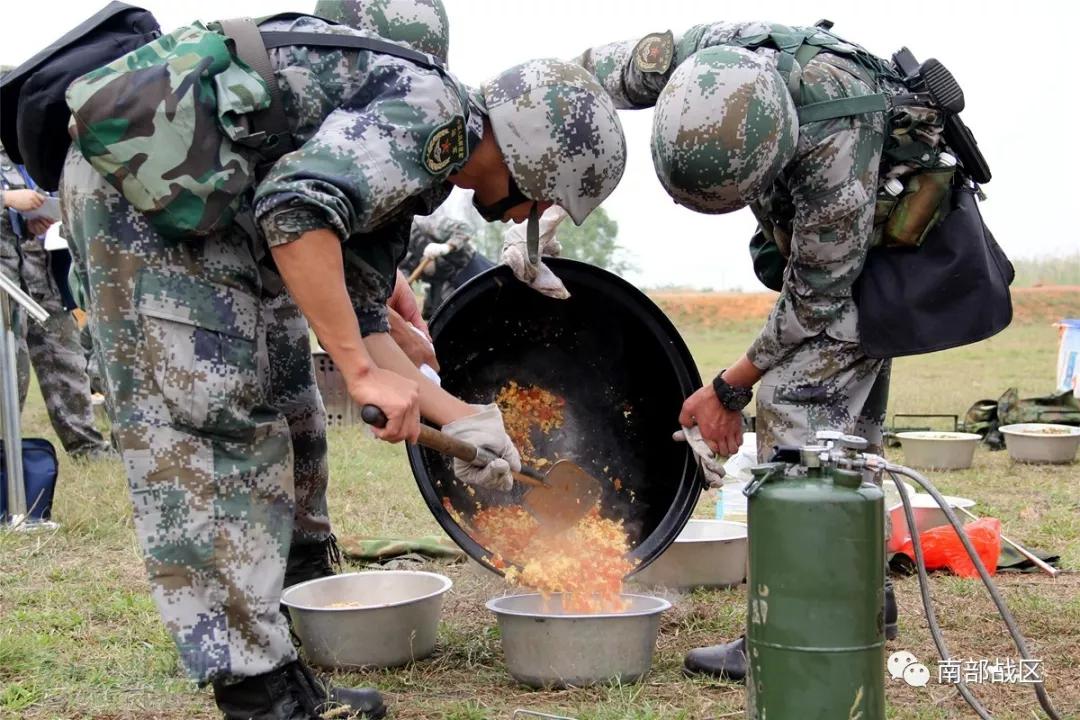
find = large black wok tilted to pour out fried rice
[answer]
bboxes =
[408,259,701,567]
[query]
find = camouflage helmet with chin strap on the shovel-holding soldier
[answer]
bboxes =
[473,59,626,225]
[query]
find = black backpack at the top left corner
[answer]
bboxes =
[0,0,161,192]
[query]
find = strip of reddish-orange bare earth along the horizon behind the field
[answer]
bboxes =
[649,285,1080,328]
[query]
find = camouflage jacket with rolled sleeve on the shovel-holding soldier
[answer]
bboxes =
[255,17,483,323]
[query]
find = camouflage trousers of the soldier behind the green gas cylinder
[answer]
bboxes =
[755,332,891,462]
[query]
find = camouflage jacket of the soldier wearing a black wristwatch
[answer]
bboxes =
[578,23,899,370]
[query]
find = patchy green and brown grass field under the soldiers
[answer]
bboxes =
[0,290,1080,720]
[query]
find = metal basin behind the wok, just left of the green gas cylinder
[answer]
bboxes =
[631,519,746,590]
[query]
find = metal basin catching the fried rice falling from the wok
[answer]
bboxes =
[487,594,672,688]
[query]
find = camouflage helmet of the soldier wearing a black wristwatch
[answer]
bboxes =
[652,46,799,214]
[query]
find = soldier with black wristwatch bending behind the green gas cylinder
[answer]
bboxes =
[579,23,902,679]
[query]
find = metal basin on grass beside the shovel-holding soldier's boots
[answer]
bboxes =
[281,570,453,667]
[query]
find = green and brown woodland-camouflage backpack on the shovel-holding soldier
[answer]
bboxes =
[67,13,457,240]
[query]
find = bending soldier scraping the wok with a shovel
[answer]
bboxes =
[62,8,625,718]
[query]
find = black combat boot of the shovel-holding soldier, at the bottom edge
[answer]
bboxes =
[214,661,387,720]
